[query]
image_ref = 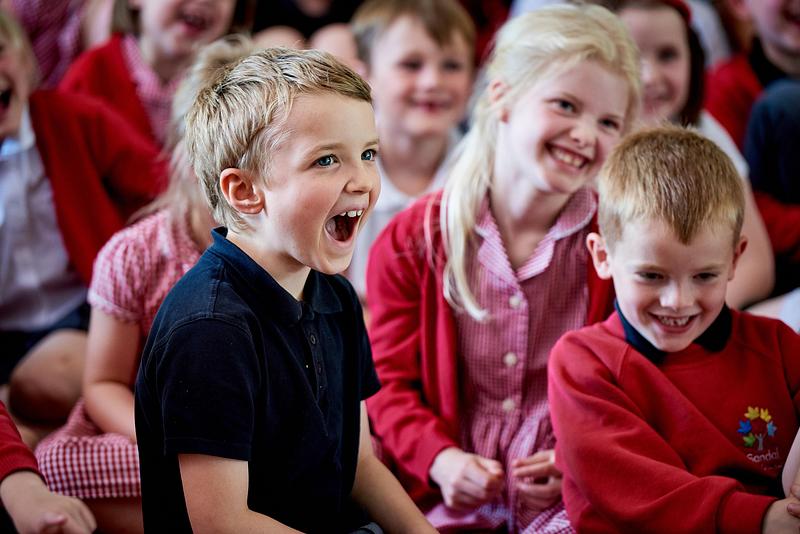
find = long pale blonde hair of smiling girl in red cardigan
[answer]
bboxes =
[440,5,641,320]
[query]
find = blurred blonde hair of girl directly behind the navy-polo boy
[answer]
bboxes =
[132,35,255,221]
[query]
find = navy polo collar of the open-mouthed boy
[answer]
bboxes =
[209,227,342,324]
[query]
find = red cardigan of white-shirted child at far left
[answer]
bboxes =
[30,91,163,285]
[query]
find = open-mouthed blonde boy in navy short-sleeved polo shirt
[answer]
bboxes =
[135,49,430,532]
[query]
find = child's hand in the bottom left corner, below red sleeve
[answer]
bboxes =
[0,471,97,534]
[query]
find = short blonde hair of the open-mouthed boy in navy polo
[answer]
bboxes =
[186,48,372,230]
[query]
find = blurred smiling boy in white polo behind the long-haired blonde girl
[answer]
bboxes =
[348,0,475,297]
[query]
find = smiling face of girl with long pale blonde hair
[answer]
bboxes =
[495,61,629,195]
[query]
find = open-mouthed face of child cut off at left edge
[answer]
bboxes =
[0,35,33,144]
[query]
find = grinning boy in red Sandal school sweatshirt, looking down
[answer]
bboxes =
[549,126,800,533]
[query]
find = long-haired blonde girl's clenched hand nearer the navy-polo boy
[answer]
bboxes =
[430,447,504,510]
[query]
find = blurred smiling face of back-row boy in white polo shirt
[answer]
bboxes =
[368,16,472,141]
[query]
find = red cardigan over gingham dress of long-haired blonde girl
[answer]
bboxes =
[367,192,614,507]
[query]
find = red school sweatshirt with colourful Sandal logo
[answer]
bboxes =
[548,311,800,534]
